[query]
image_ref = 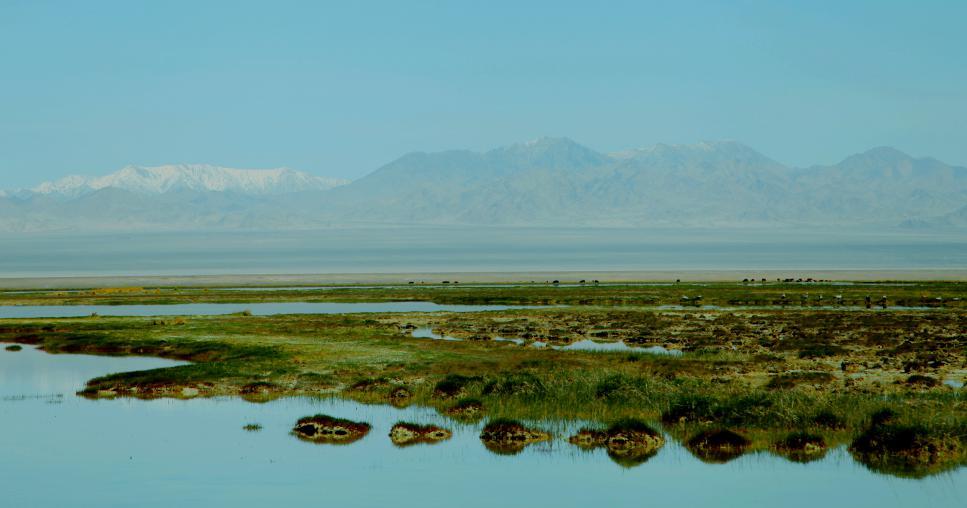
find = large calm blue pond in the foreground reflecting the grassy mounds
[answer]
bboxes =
[0,347,967,508]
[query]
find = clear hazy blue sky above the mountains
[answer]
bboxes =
[0,0,967,188]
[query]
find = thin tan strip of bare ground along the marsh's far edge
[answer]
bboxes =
[0,269,967,290]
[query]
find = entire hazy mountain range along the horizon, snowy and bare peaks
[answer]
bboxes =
[0,138,967,231]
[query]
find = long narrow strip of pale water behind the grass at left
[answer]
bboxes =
[0,302,540,319]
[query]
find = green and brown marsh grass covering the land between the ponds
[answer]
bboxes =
[0,283,967,476]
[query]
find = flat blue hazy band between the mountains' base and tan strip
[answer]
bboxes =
[0,227,967,277]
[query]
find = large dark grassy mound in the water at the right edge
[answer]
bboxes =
[849,421,964,478]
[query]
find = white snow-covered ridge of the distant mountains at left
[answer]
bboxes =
[31,164,349,197]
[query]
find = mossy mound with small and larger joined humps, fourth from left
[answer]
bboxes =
[568,419,665,467]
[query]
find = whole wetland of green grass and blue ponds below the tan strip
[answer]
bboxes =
[0,281,967,506]
